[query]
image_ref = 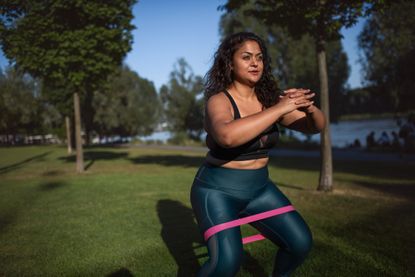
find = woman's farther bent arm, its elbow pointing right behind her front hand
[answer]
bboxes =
[279,90,326,134]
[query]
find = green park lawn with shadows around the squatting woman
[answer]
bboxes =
[0,146,415,276]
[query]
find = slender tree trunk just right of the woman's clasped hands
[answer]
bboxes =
[317,40,333,191]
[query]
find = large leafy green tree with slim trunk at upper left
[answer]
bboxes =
[0,0,135,172]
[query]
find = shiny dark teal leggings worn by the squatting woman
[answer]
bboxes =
[191,164,312,277]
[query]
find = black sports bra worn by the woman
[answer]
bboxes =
[206,90,279,161]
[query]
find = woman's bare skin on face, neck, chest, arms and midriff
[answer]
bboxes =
[205,38,325,169]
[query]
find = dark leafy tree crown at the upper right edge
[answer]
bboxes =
[359,1,415,112]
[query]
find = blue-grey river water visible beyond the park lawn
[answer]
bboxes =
[141,118,399,147]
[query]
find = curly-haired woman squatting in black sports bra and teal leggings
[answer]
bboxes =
[191,32,325,276]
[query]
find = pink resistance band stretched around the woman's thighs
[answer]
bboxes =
[204,205,295,244]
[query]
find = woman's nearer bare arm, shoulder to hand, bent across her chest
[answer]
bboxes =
[206,90,310,148]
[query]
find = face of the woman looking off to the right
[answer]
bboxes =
[232,40,264,85]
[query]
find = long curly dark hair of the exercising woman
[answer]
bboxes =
[205,32,279,108]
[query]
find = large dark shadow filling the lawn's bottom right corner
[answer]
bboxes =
[310,199,415,276]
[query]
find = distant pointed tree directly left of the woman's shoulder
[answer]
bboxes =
[160,58,203,140]
